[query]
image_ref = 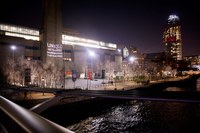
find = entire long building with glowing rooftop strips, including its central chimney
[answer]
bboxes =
[0,0,122,77]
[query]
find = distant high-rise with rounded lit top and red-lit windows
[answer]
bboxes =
[163,15,182,60]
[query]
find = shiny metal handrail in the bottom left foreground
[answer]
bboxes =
[0,96,74,133]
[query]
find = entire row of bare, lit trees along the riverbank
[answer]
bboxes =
[0,54,178,88]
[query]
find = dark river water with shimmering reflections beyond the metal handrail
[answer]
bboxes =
[35,87,200,133]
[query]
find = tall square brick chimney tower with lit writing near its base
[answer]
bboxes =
[40,0,63,66]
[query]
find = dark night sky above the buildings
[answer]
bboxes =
[0,0,200,55]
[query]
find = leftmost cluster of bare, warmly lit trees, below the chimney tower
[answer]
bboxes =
[3,57,64,88]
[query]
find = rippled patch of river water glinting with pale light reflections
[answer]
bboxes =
[67,101,152,133]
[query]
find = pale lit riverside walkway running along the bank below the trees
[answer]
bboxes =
[1,77,191,99]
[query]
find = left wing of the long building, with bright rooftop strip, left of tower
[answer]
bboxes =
[0,23,41,61]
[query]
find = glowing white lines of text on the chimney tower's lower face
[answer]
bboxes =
[47,43,63,58]
